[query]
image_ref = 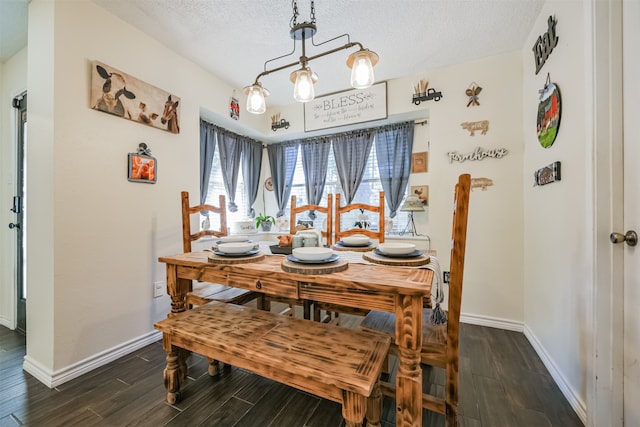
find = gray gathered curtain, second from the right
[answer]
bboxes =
[333,129,374,205]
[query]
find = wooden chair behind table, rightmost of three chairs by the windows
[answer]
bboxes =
[313,191,384,324]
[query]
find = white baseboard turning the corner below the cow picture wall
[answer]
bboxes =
[22,331,162,388]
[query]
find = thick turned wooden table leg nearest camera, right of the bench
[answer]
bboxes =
[396,295,422,427]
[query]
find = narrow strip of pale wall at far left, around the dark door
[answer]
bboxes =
[0,48,27,329]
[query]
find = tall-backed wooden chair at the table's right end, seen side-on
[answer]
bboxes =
[360,174,471,427]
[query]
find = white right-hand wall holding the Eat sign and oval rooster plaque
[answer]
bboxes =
[522,1,594,419]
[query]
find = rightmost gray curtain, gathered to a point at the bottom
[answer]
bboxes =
[375,122,415,218]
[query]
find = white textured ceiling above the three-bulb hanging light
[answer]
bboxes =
[0,0,545,106]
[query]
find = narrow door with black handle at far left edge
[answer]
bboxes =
[9,93,27,334]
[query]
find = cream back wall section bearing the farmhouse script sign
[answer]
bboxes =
[420,52,523,324]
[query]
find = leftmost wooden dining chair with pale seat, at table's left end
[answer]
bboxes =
[181,191,265,309]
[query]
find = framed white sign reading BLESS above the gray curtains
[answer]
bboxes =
[304,82,387,132]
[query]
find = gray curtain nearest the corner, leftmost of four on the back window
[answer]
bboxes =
[267,141,300,217]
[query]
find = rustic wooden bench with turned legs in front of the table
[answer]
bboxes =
[155,302,391,427]
